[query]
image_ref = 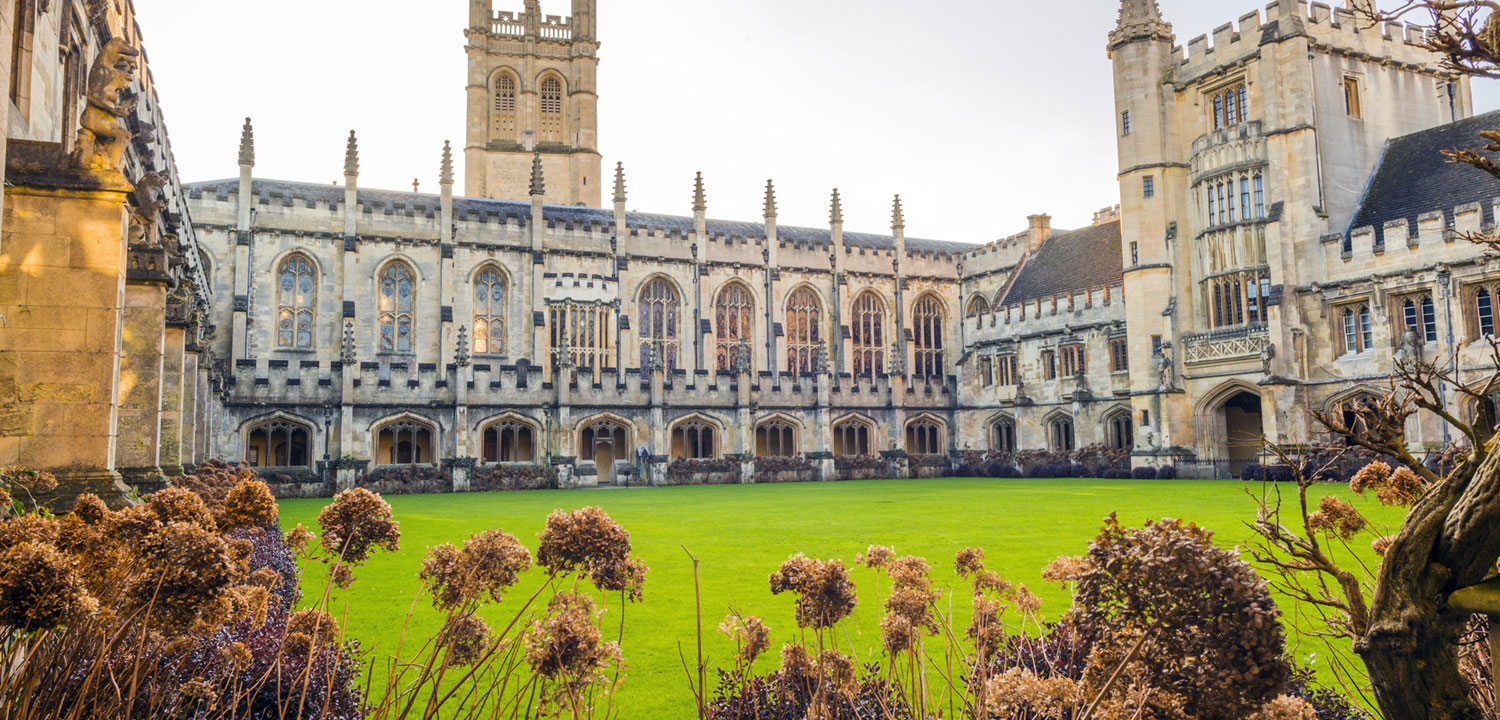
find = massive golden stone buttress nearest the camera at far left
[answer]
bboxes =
[0,161,131,510]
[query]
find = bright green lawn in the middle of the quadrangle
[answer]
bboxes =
[281,480,1400,719]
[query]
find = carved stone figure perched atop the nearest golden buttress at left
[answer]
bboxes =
[74,38,141,173]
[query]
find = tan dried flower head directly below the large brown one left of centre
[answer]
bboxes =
[525,593,621,680]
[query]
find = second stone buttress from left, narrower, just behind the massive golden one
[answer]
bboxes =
[116,248,168,492]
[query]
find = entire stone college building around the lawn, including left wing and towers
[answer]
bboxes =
[0,0,1500,494]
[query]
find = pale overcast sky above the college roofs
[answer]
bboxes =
[135,0,1500,243]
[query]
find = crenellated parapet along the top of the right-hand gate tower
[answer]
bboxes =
[1173,0,1437,84]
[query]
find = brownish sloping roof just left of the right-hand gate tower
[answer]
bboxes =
[1004,221,1125,305]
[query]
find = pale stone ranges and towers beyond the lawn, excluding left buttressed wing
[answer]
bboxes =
[175,0,1500,485]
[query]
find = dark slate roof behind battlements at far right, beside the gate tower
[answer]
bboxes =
[1349,111,1500,245]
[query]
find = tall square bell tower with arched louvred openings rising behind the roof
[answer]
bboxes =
[464,0,603,207]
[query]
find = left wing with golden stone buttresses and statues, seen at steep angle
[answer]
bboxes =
[0,0,219,504]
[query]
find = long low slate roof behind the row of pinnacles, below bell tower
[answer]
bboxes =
[188,179,978,254]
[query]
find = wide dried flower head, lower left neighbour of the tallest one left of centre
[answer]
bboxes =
[420,530,531,611]
